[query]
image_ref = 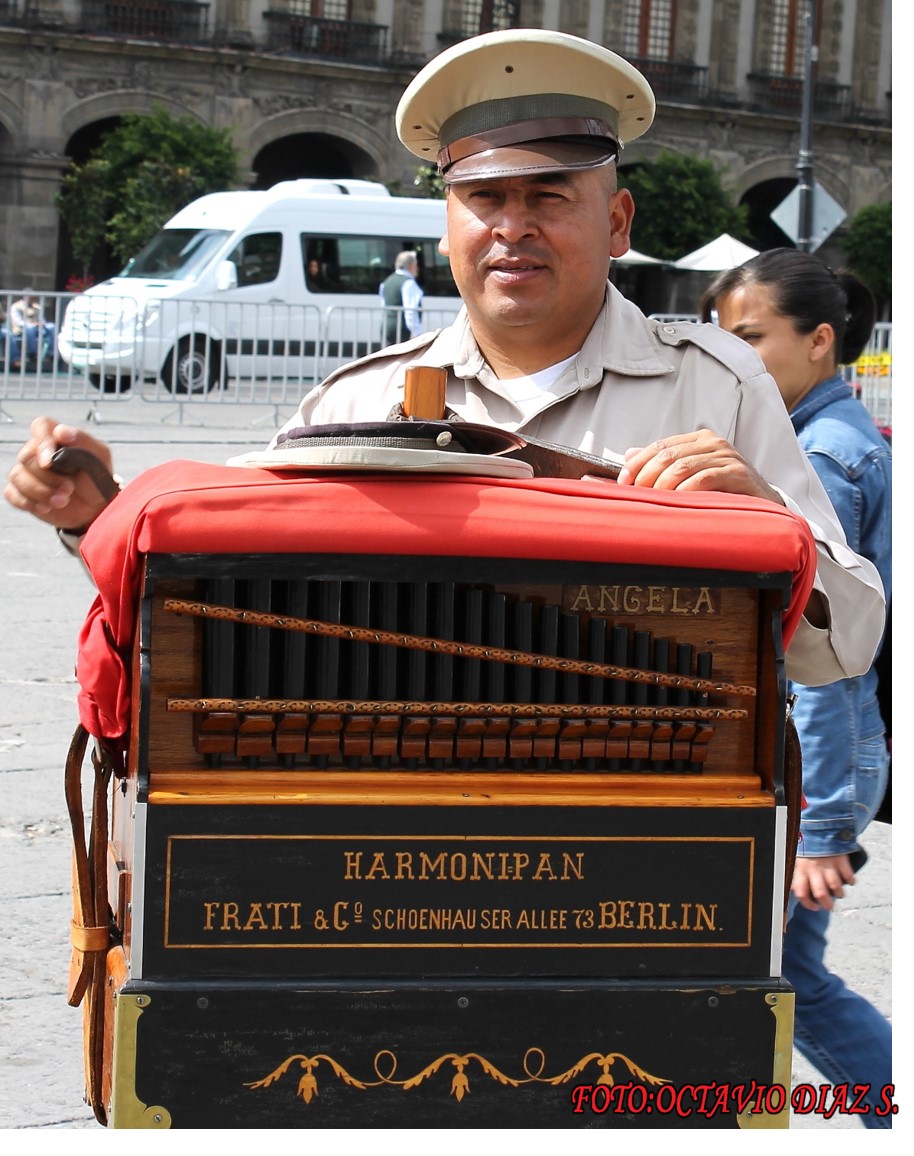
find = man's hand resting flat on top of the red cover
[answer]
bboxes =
[618,430,783,505]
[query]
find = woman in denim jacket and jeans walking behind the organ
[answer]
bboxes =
[701,249,892,1128]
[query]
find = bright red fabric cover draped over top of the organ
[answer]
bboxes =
[76,461,816,744]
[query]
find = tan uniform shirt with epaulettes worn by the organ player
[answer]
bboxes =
[274,286,885,686]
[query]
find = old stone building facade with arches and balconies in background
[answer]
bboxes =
[0,0,891,289]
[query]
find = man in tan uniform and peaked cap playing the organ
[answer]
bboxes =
[6,29,885,684]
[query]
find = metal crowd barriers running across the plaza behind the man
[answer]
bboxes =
[0,290,892,430]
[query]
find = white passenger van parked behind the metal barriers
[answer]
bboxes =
[58,179,460,394]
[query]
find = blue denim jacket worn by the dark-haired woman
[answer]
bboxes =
[790,376,892,857]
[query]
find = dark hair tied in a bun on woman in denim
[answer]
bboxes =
[700,249,876,365]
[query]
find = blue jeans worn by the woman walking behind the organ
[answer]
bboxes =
[783,749,892,1128]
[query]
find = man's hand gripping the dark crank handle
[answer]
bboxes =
[3,417,111,529]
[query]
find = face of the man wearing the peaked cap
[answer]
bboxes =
[439,168,634,340]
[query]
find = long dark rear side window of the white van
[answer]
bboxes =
[302,234,458,298]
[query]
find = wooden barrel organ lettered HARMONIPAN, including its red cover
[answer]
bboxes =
[67,466,815,1128]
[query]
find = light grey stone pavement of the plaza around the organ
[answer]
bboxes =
[0,400,912,1133]
